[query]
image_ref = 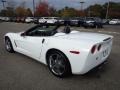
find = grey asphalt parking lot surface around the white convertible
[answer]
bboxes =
[0,22,120,90]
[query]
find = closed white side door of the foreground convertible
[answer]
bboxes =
[15,25,45,59]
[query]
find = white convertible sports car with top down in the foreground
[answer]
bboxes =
[5,25,113,77]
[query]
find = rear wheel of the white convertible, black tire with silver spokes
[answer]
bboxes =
[47,50,71,78]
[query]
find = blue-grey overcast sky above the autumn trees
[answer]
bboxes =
[0,0,120,9]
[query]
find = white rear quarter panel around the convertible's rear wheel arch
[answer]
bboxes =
[40,37,99,73]
